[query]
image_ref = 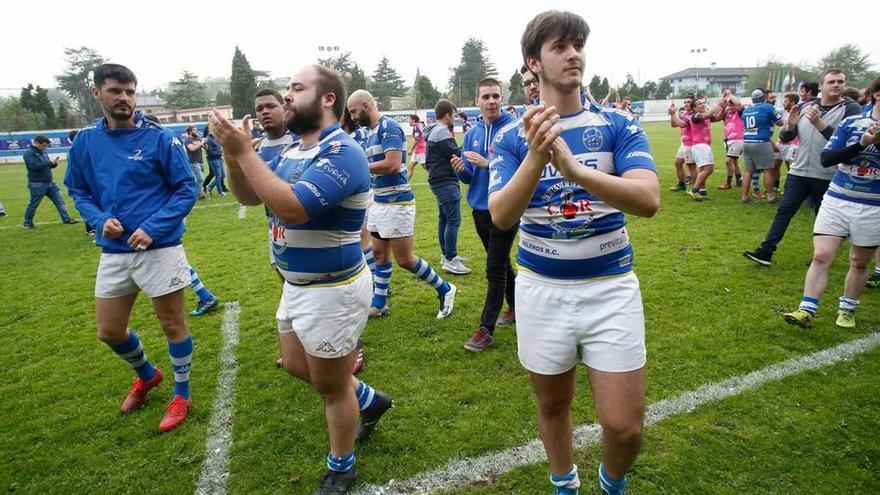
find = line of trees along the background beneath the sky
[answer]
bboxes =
[0,42,878,132]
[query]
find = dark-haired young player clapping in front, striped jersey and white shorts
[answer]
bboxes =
[489,11,660,495]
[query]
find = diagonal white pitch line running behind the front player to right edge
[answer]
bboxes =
[355,333,880,495]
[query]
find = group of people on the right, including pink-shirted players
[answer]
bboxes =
[669,68,880,334]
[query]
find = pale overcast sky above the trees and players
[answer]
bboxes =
[0,0,880,95]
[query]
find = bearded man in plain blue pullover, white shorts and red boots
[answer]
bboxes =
[64,64,197,432]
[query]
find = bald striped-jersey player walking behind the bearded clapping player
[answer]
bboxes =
[348,89,457,320]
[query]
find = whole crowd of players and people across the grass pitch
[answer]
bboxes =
[0,11,880,495]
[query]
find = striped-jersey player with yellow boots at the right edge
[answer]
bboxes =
[785,78,880,328]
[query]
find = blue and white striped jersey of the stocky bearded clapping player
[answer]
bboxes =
[269,125,370,285]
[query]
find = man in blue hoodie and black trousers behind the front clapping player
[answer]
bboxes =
[452,77,516,352]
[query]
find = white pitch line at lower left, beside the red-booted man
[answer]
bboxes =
[195,301,241,495]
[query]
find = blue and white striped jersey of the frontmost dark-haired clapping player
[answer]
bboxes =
[489,104,656,279]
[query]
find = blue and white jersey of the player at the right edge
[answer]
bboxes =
[825,110,880,206]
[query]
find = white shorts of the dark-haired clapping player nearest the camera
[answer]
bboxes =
[516,270,647,375]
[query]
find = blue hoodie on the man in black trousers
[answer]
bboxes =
[457,112,517,211]
